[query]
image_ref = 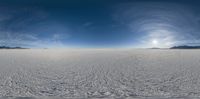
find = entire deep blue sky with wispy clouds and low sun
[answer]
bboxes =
[0,0,200,48]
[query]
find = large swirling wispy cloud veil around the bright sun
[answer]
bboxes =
[113,2,200,47]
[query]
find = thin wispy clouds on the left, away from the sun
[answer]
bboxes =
[0,7,70,48]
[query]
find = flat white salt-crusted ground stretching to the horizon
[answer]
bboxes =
[0,49,200,99]
